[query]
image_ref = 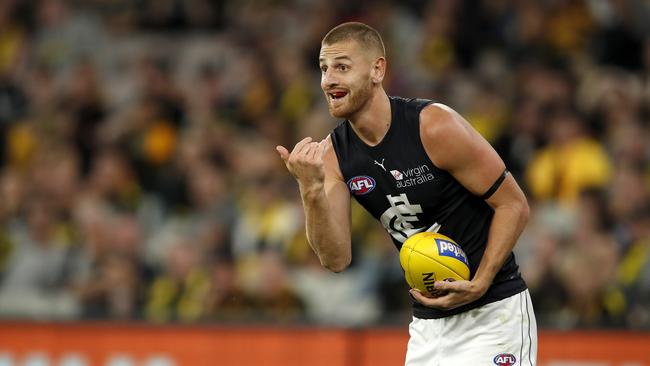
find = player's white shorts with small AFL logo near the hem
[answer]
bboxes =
[405,290,537,366]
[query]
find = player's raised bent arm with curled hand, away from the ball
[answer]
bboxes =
[276,137,352,272]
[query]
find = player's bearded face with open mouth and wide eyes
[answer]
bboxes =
[319,41,374,118]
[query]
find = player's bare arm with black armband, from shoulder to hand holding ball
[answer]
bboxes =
[411,104,529,309]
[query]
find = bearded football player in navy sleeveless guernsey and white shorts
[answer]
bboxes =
[277,22,537,366]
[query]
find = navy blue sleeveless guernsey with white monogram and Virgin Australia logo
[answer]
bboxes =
[331,97,526,319]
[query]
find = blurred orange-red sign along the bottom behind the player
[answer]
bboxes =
[0,322,650,366]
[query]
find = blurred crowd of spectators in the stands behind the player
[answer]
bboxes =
[0,0,650,329]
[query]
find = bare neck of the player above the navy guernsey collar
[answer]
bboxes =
[348,88,391,146]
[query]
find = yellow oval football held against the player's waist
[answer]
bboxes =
[399,232,469,297]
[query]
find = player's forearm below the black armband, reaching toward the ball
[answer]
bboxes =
[473,200,529,290]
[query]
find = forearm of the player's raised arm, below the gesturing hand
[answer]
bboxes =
[300,184,352,272]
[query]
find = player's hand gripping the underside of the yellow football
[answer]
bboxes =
[409,280,488,310]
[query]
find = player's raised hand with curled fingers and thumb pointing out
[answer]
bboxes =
[276,136,329,187]
